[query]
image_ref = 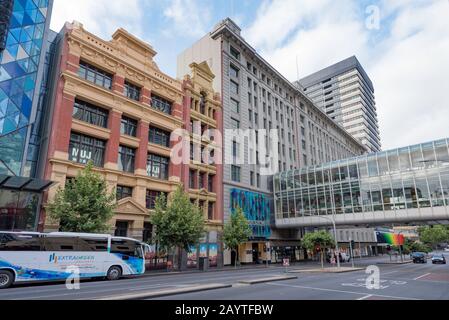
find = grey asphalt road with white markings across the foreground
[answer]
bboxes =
[0,252,449,300]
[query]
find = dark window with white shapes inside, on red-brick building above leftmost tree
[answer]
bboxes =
[69,133,106,167]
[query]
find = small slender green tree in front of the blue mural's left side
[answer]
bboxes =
[223,207,252,267]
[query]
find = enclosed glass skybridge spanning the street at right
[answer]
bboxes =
[274,139,449,228]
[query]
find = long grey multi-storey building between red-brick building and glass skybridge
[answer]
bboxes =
[177,18,366,264]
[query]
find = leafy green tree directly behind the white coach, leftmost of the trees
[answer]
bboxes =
[48,161,116,233]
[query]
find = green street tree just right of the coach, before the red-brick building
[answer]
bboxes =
[150,186,205,269]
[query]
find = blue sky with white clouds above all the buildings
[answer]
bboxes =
[51,0,449,150]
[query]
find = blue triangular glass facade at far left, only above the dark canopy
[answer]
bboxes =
[0,0,53,176]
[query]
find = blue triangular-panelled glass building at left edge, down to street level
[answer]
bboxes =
[0,0,53,231]
